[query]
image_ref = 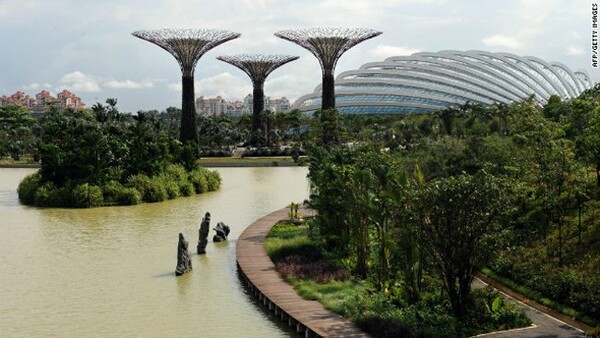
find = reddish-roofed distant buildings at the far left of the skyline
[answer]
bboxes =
[0,89,85,112]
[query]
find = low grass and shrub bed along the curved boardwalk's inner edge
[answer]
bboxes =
[265,220,530,338]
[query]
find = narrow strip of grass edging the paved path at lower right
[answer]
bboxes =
[481,268,600,326]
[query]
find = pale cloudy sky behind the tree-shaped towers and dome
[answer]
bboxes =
[0,0,600,112]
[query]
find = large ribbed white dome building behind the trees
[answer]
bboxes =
[293,51,593,114]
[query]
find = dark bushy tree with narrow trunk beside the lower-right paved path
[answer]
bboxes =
[414,172,508,318]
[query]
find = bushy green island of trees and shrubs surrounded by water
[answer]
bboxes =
[18,100,220,207]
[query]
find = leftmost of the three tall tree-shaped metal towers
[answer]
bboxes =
[132,29,241,144]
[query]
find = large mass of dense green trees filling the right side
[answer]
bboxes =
[309,87,600,332]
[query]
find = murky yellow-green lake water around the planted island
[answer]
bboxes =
[0,167,308,337]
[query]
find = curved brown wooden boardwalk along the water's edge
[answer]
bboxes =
[236,208,368,337]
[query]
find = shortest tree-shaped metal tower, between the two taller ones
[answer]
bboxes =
[217,54,298,145]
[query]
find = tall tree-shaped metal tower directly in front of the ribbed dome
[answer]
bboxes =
[275,27,382,109]
